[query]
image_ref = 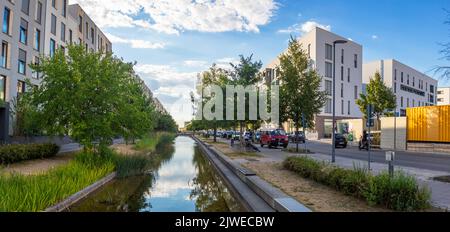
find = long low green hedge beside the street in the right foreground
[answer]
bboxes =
[283,157,431,211]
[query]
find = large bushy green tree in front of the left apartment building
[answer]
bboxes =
[31,45,154,149]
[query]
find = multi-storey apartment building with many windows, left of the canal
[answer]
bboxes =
[0,0,112,141]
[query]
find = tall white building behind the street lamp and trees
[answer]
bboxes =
[264,27,363,139]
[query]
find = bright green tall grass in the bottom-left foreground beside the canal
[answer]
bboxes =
[0,153,114,212]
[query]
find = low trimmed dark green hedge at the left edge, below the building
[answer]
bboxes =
[0,143,59,165]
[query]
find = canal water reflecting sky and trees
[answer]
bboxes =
[69,136,243,212]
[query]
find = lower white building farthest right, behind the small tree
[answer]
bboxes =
[363,59,438,116]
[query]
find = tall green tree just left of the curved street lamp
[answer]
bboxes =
[277,37,327,152]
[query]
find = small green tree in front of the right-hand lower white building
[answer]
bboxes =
[356,72,397,125]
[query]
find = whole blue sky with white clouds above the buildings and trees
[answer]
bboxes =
[70,0,450,125]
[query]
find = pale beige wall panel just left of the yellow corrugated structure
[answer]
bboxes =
[381,117,407,150]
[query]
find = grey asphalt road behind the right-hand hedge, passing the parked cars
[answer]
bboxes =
[289,141,450,172]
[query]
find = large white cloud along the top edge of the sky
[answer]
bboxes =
[74,0,278,34]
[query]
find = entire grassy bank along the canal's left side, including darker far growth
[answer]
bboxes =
[0,134,174,212]
